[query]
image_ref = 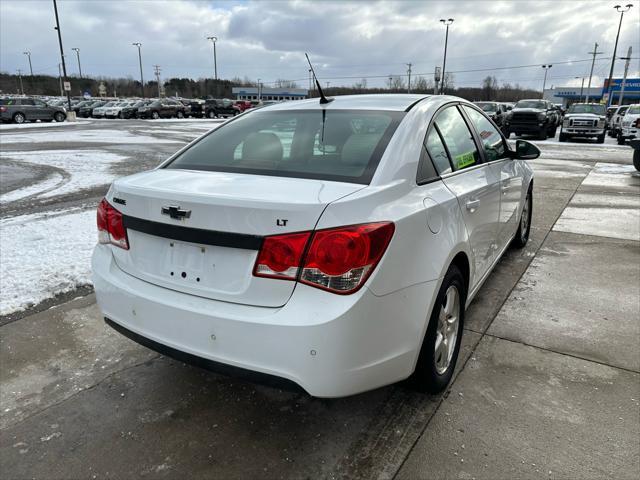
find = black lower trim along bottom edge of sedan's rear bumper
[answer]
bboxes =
[104,317,305,393]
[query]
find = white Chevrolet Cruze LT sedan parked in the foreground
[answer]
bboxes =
[92,95,540,397]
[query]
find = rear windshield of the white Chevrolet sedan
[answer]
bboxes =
[165,110,405,184]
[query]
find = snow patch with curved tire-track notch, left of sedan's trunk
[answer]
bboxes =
[0,150,126,204]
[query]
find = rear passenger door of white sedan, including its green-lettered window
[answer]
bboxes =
[425,105,500,289]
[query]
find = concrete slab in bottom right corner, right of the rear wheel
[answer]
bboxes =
[396,337,640,480]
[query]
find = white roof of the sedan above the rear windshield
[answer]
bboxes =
[261,93,429,112]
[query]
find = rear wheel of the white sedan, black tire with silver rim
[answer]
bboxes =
[409,265,467,393]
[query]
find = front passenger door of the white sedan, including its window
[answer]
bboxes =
[462,105,524,250]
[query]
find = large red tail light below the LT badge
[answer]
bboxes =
[253,222,395,294]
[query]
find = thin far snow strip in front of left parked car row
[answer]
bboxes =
[0,130,182,145]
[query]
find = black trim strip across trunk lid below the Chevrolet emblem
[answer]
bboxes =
[122,215,263,250]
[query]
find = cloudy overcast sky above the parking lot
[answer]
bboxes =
[0,0,640,89]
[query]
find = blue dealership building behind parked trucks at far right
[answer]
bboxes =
[543,78,640,107]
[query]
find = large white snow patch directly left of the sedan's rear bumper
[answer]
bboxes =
[0,210,97,315]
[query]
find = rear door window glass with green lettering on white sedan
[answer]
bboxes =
[435,107,480,170]
